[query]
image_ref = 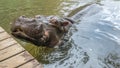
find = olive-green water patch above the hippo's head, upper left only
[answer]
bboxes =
[0,0,61,32]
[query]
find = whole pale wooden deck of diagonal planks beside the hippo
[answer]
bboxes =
[0,27,43,68]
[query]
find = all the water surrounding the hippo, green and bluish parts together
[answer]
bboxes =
[0,0,120,68]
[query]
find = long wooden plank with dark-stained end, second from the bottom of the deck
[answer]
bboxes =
[0,51,40,68]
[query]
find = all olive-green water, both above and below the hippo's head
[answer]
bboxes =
[0,0,75,63]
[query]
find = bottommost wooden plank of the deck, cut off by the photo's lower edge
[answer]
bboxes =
[18,59,43,68]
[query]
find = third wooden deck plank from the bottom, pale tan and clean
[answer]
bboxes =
[0,44,25,61]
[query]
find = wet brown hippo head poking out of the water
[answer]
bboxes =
[11,15,74,47]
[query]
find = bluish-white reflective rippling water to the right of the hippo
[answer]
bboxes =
[53,0,120,68]
